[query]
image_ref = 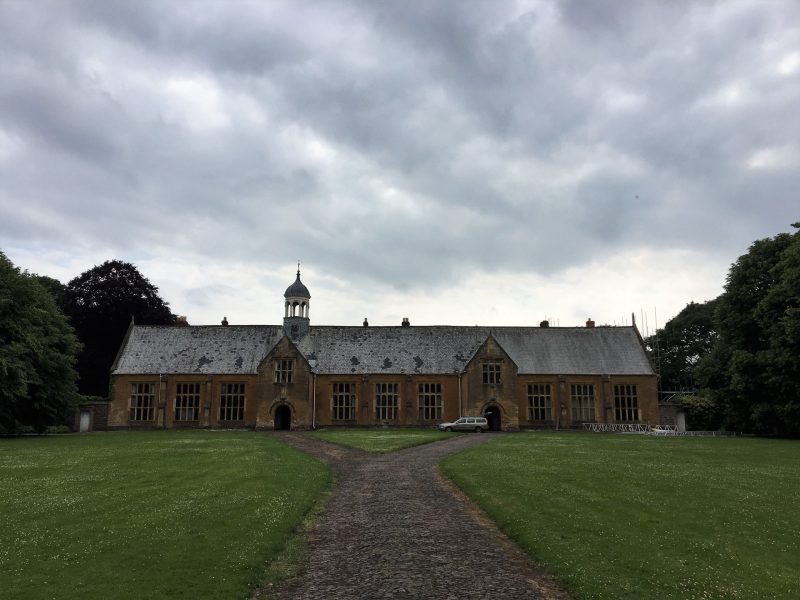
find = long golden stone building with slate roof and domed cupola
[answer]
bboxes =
[108,270,659,430]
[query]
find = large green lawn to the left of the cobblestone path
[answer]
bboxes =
[0,431,330,600]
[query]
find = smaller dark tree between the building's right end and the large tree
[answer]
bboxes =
[645,300,717,391]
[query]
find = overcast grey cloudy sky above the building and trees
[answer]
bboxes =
[0,0,800,330]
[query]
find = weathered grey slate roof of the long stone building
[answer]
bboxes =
[113,325,653,375]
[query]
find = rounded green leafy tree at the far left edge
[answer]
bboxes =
[0,252,80,433]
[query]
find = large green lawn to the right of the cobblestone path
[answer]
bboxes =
[442,433,800,600]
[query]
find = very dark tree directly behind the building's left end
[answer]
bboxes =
[63,260,175,396]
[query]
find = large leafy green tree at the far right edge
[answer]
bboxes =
[698,224,800,436]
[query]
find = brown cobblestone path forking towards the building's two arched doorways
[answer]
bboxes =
[270,432,568,599]
